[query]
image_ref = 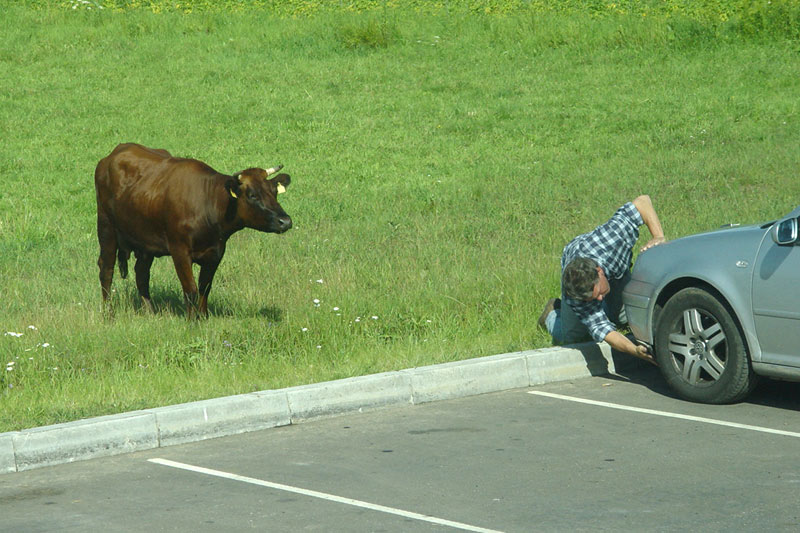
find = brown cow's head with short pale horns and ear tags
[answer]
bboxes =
[228,165,292,233]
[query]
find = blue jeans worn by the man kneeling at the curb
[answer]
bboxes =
[545,270,631,344]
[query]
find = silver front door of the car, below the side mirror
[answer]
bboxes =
[753,220,800,367]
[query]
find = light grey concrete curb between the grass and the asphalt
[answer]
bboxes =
[0,343,638,474]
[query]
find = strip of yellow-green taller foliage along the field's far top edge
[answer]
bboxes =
[47,0,800,42]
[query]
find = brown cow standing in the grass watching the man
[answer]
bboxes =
[94,144,292,318]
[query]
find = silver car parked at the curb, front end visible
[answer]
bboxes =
[623,207,800,403]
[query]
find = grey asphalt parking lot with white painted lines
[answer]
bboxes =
[0,366,800,532]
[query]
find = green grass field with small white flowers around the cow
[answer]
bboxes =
[0,2,800,431]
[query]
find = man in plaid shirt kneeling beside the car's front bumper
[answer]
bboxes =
[539,195,664,361]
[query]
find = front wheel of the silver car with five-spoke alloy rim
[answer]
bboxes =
[655,288,756,403]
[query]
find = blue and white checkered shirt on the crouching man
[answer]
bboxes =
[561,202,644,342]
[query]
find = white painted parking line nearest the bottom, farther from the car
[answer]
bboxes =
[148,459,502,533]
